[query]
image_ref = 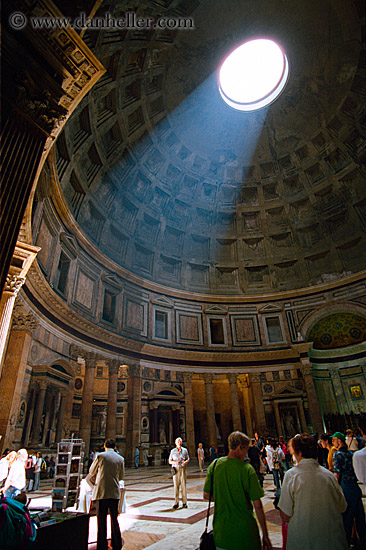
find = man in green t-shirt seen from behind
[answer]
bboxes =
[203,432,272,550]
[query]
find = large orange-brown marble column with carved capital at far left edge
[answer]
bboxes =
[0,304,37,449]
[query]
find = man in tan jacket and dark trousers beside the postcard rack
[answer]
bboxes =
[86,439,125,550]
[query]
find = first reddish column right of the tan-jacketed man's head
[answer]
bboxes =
[126,363,141,466]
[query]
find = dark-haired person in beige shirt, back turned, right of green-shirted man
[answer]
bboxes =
[278,434,348,550]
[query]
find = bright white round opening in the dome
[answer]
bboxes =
[219,38,289,111]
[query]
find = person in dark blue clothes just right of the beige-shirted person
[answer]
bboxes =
[332,432,366,548]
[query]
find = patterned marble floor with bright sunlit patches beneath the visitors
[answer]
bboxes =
[28,463,282,550]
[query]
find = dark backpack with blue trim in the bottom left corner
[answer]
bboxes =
[0,497,37,550]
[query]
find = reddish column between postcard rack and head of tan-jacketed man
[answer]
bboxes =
[79,352,98,456]
